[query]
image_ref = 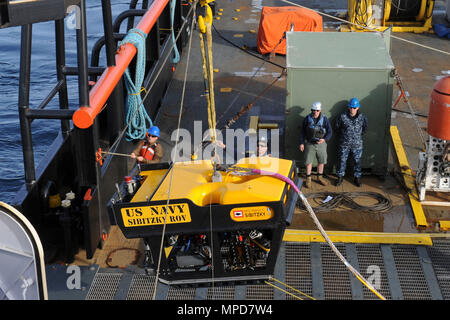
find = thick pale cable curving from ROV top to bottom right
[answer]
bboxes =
[227,167,386,300]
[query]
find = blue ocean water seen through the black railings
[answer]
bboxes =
[0,0,134,203]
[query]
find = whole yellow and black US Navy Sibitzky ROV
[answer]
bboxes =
[109,157,301,285]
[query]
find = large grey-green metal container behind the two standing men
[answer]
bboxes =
[284,32,394,175]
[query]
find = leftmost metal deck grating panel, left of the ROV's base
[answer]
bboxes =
[86,273,123,300]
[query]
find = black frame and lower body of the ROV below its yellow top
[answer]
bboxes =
[108,162,302,285]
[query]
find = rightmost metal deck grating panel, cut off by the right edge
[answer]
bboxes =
[427,240,450,300]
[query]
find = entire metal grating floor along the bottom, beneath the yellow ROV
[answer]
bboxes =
[78,240,450,300]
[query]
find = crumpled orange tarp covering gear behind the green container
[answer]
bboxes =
[258,7,323,54]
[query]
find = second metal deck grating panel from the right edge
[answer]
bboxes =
[392,245,431,300]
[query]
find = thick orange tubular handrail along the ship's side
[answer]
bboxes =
[72,0,169,129]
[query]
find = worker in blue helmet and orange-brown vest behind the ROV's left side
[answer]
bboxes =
[130,126,164,164]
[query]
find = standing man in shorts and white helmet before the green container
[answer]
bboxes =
[300,102,333,188]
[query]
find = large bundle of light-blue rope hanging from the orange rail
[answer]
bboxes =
[119,29,153,141]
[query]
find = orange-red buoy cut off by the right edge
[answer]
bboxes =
[427,76,450,140]
